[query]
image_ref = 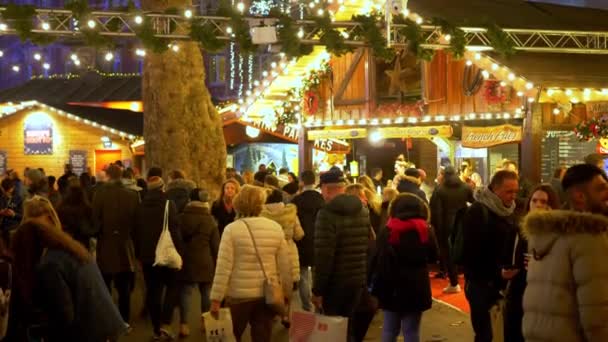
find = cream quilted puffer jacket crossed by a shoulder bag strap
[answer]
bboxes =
[210,217,293,301]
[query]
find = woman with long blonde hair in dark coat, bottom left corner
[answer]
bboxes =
[10,196,128,342]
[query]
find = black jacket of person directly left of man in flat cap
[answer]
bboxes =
[291,190,325,268]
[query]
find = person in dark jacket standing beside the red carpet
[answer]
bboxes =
[430,166,475,293]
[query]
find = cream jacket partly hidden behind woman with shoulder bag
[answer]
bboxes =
[260,203,304,281]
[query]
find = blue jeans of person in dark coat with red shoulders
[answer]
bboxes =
[382,310,422,342]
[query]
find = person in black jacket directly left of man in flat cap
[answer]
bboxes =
[292,170,325,311]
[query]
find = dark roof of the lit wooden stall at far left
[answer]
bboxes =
[0,72,141,105]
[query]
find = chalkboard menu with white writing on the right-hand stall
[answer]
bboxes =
[541,131,597,182]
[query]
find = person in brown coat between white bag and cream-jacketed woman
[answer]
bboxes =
[178,188,220,336]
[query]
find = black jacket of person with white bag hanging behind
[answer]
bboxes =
[133,189,184,265]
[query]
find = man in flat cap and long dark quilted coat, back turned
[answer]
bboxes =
[312,171,371,341]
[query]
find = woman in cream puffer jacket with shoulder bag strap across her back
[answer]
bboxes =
[210,185,293,342]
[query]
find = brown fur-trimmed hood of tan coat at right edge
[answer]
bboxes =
[522,210,608,259]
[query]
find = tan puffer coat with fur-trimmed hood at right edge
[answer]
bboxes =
[523,210,608,342]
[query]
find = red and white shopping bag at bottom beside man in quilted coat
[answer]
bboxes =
[289,311,348,342]
